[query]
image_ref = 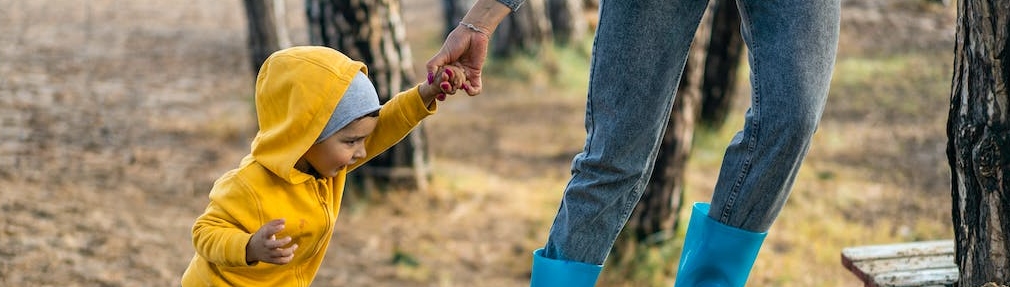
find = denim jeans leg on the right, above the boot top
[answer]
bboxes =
[708,0,840,232]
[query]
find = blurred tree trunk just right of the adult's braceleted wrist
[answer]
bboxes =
[491,0,550,57]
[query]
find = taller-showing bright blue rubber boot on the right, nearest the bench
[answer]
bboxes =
[674,202,768,287]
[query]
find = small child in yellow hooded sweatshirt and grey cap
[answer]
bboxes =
[182,46,467,286]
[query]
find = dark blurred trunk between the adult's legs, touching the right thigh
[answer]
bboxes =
[700,0,743,128]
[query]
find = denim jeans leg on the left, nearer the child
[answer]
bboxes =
[543,0,708,265]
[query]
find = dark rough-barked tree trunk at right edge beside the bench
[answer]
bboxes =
[947,0,1010,287]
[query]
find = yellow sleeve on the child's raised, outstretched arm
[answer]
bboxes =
[348,86,438,171]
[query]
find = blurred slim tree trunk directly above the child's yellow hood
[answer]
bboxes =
[242,0,291,78]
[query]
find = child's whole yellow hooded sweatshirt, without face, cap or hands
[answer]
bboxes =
[182,46,435,286]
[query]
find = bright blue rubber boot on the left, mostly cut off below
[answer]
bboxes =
[529,249,603,287]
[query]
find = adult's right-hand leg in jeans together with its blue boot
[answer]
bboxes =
[676,0,839,287]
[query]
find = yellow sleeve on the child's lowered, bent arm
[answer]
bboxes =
[193,176,263,267]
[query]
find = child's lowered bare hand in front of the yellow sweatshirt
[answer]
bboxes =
[245,219,298,265]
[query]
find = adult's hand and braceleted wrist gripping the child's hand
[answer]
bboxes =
[425,0,512,96]
